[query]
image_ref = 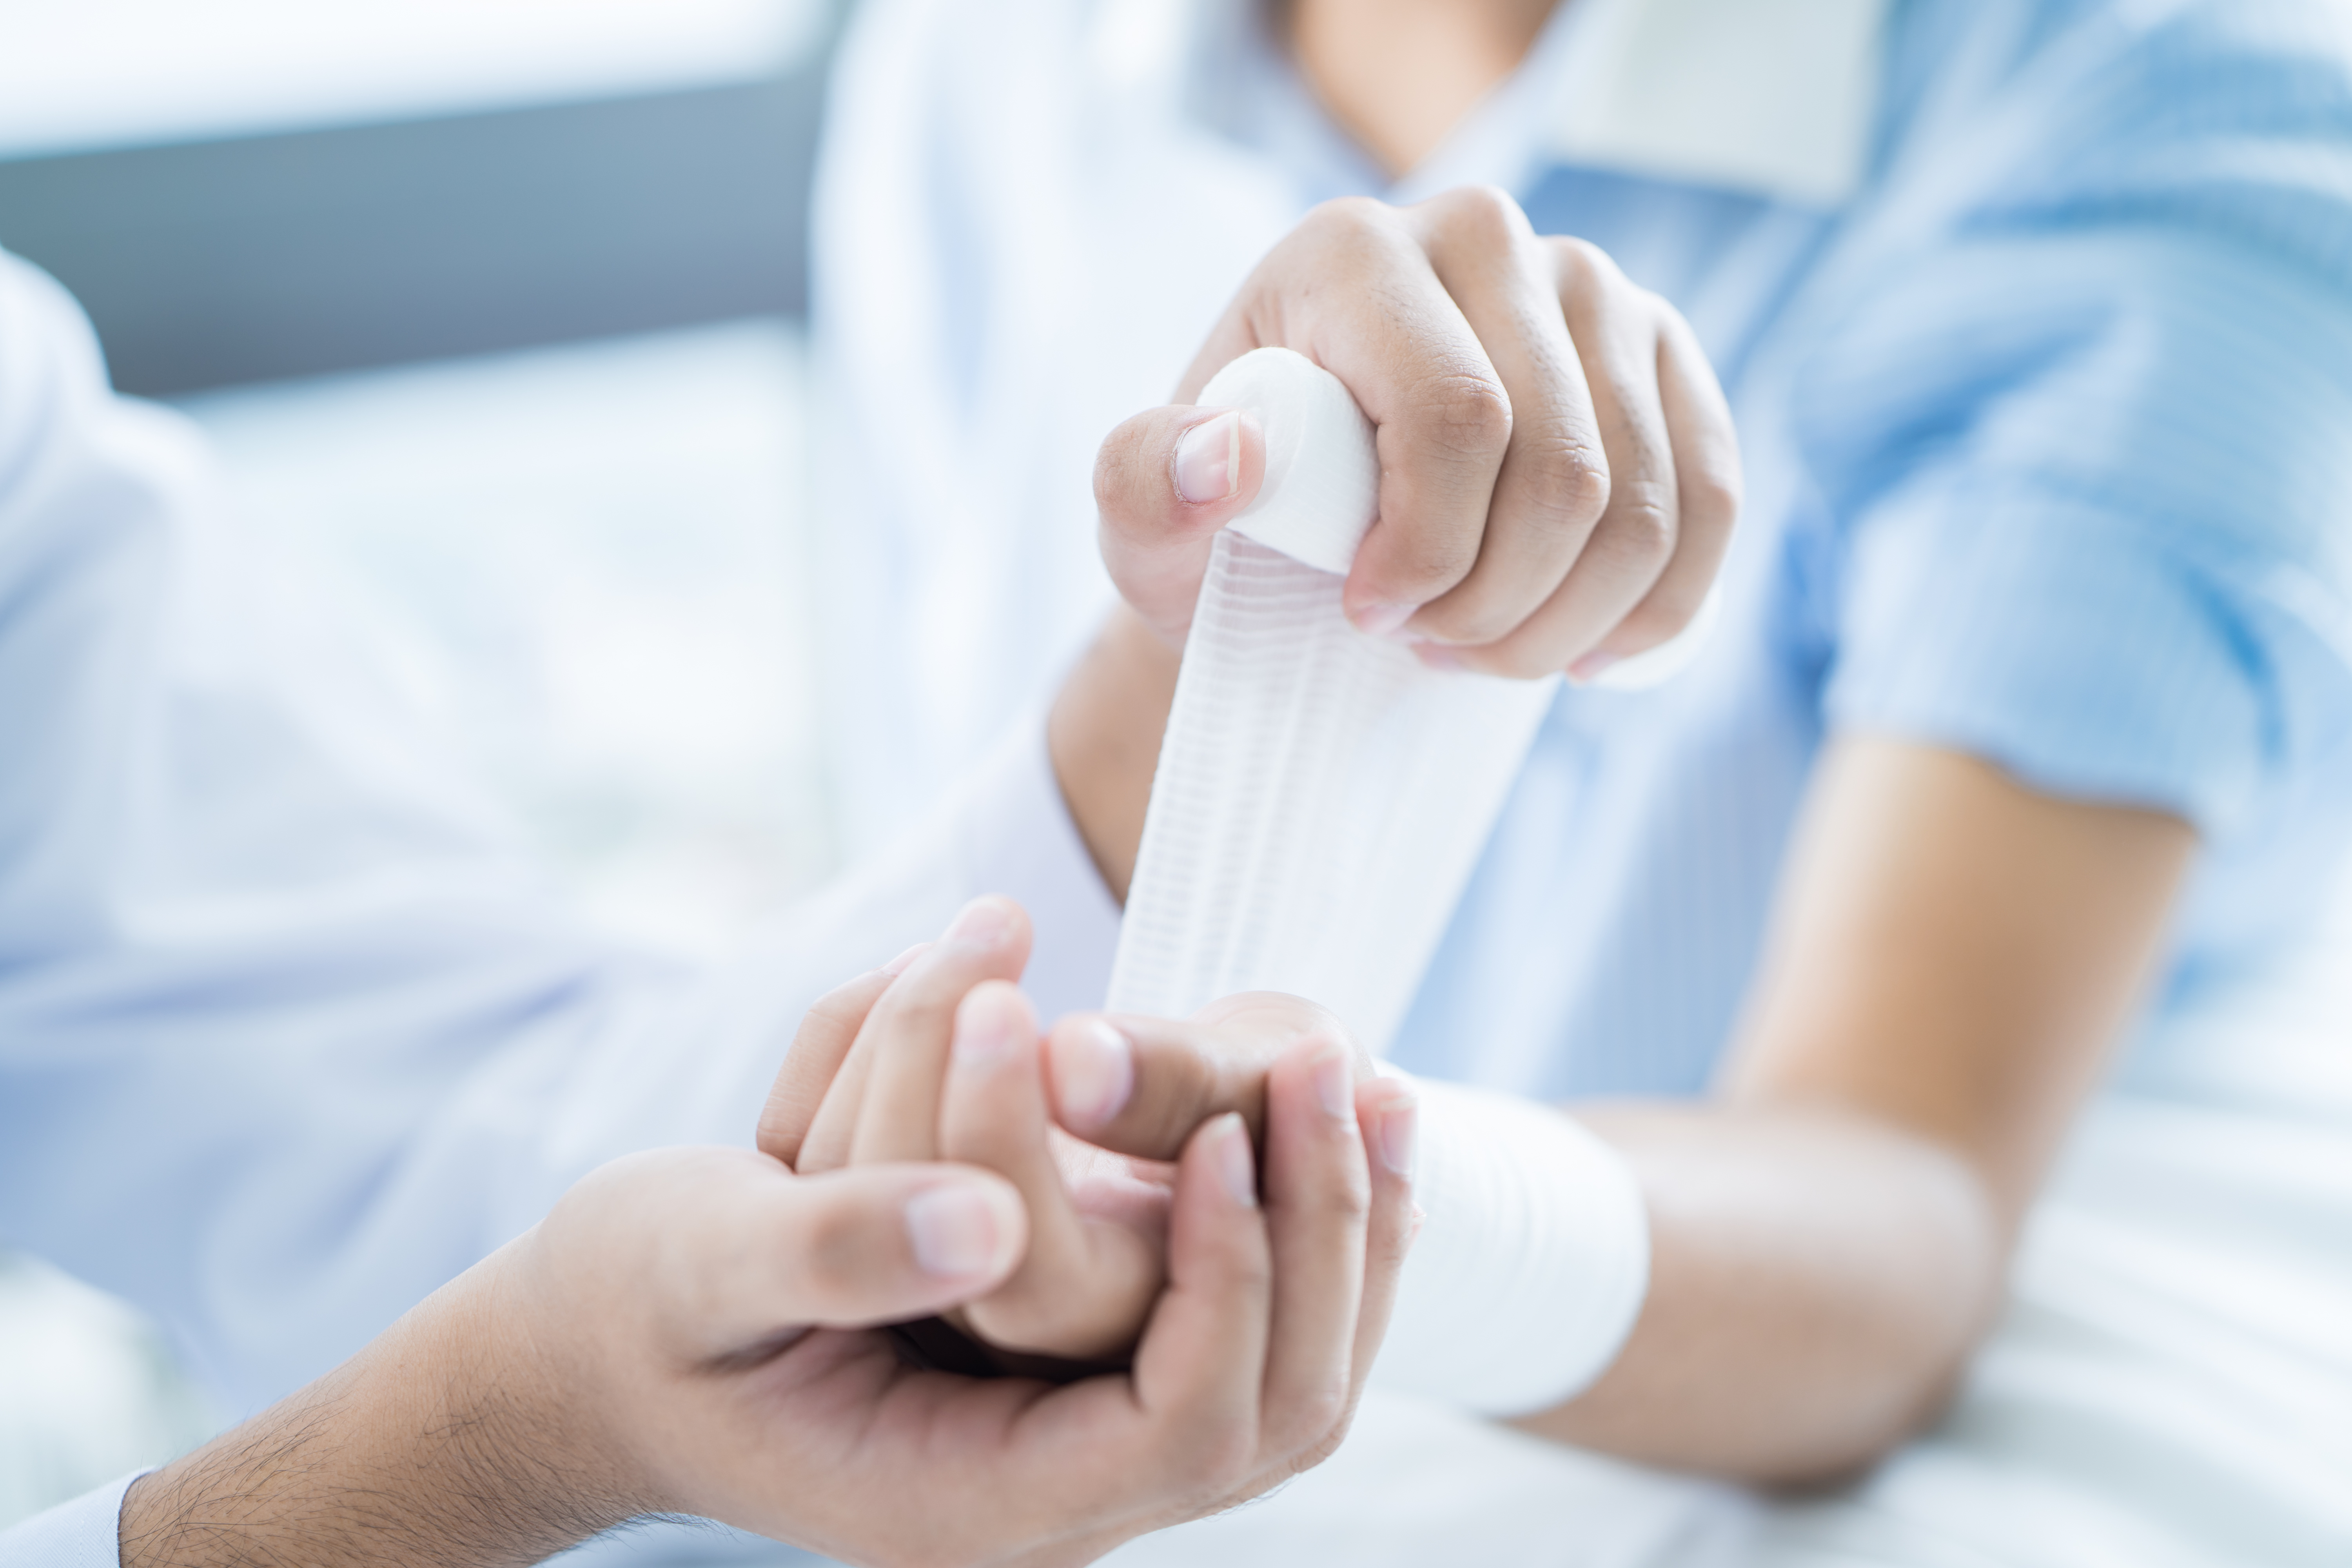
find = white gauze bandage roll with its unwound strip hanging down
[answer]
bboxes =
[1110,348,1555,1053]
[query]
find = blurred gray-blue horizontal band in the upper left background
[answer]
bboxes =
[0,49,830,395]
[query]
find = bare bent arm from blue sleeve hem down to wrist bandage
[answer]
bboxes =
[1526,736,2194,1481]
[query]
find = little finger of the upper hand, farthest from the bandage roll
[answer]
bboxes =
[1569,310,1740,679]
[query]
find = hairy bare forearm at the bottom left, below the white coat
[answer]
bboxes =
[120,1258,637,1568]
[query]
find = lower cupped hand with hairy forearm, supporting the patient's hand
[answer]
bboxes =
[120,905,1411,1568]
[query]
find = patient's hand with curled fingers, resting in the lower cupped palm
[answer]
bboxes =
[760,898,1374,1361]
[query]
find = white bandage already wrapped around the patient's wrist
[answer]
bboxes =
[1371,1079,1649,1415]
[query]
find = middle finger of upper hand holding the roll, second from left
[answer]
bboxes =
[1404,191,1609,646]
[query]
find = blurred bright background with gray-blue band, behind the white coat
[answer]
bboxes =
[0,0,842,1526]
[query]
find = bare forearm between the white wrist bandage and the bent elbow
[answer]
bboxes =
[1517,1105,2006,1486]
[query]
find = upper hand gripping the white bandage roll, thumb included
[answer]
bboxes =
[1096,188,1740,679]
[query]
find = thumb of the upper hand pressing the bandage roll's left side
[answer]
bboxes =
[1094,404,1265,644]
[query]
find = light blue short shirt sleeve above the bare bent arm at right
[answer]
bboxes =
[1799,9,2352,837]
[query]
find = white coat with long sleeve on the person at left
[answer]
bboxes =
[0,256,1117,1568]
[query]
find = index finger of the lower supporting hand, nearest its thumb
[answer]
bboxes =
[1134,1117,1275,1457]
